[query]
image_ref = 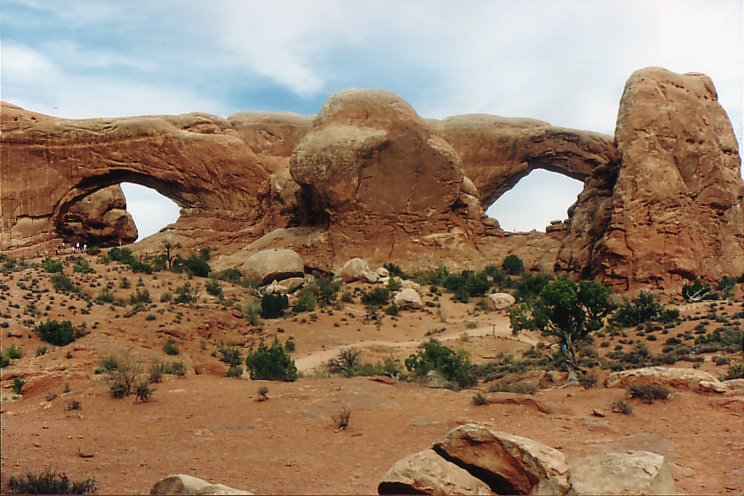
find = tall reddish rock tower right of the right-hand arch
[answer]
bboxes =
[580,67,744,289]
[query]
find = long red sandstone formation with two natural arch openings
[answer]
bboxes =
[0,68,744,290]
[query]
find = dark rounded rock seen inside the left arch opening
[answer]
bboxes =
[57,185,137,246]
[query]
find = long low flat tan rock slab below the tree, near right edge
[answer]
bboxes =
[605,367,728,392]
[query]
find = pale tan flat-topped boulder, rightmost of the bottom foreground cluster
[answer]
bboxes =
[568,451,677,496]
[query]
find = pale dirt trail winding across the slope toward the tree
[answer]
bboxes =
[295,323,537,372]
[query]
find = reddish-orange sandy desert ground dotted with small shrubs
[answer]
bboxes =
[0,255,744,494]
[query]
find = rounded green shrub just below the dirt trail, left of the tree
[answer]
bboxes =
[405,338,477,388]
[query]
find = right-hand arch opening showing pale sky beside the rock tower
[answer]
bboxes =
[486,169,584,232]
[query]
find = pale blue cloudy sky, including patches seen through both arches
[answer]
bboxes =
[0,0,744,240]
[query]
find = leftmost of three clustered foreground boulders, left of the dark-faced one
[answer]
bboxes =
[377,449,492,496]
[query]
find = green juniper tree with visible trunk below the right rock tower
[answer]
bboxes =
[509,278,612,382]
